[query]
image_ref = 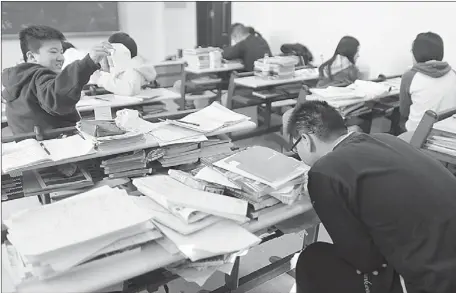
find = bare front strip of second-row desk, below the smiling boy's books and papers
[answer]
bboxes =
[3,121,256,173]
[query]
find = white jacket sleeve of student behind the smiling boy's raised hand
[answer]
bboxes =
[97,69,143,96]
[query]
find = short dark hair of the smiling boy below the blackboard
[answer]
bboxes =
[19,25,65,62]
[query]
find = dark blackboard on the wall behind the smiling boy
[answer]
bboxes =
[2,1,119,37]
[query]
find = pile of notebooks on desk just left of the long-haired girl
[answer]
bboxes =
[254,56,297,79]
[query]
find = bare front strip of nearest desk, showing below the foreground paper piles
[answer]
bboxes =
[7,197,312,293]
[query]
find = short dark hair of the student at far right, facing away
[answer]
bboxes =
[412,32,443,63]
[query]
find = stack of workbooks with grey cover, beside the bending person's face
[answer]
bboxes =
[195,146,309,210]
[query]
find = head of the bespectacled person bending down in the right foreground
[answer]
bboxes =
[287,101,347,166]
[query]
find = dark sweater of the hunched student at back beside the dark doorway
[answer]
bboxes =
[223,35,271,72]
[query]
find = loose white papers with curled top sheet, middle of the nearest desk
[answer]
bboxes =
[133,175,261,261]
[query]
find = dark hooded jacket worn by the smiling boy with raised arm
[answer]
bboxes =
[2,55,100,135]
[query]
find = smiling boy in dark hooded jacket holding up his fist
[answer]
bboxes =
[2,25,112,135]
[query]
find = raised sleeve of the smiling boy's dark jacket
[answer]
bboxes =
[35,54,99,116]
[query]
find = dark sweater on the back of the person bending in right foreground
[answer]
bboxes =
[308,134,456,293]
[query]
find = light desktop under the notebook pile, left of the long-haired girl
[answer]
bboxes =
[234,69,318,89]
